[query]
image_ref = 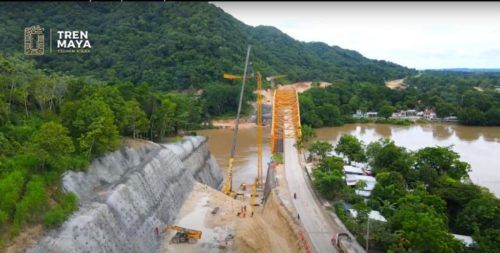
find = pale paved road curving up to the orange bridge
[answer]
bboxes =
[284,138,340,253]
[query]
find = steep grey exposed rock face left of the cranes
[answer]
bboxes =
[29,136,223,253]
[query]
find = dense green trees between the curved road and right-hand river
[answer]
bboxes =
[309,135,500,253]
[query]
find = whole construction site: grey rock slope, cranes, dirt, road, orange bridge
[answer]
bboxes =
[25,46,364,253]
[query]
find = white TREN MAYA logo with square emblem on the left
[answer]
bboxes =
[24,25,92,55]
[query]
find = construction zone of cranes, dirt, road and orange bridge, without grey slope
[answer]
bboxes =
[159,47,364,252]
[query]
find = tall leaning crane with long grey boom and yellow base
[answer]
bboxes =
[223,45,252,197]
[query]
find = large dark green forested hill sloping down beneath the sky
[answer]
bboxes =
[0,2,415,90]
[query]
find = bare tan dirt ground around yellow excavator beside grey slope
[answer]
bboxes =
[160,183,300,253]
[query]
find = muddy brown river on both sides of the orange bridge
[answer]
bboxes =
[197,124,500,197]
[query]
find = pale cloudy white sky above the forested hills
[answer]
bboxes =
[212,2,500,69]
